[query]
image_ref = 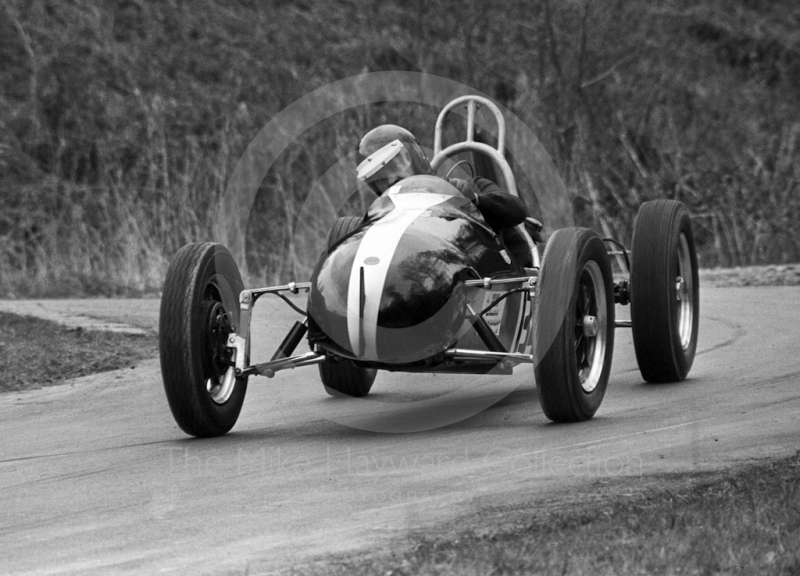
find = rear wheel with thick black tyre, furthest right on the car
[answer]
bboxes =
[631,200,700,382]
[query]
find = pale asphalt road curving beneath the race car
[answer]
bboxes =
[0,287,800,574]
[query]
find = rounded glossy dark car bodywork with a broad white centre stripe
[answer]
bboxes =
[308,176,525,370]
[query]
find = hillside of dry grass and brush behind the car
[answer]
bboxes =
[0,0,800,296]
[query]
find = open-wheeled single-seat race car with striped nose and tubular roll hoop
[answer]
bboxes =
[159,96,699,437]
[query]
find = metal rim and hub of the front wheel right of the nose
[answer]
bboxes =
[575,260,608,394]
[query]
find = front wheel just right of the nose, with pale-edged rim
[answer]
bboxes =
[533,228,614,422]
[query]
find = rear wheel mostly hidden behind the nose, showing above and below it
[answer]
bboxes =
[319,216,378,398]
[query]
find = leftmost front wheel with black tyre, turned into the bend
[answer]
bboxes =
[159,242,247,437]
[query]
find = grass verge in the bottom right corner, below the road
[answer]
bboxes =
[303,452,800,576]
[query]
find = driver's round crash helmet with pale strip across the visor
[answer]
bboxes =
[356,124,435,196]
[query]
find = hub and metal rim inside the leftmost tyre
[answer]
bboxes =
[203,300,236,404]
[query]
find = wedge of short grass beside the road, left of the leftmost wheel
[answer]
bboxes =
[0,312,158,392]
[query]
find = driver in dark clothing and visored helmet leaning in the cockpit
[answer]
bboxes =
[357,124,531,266]
